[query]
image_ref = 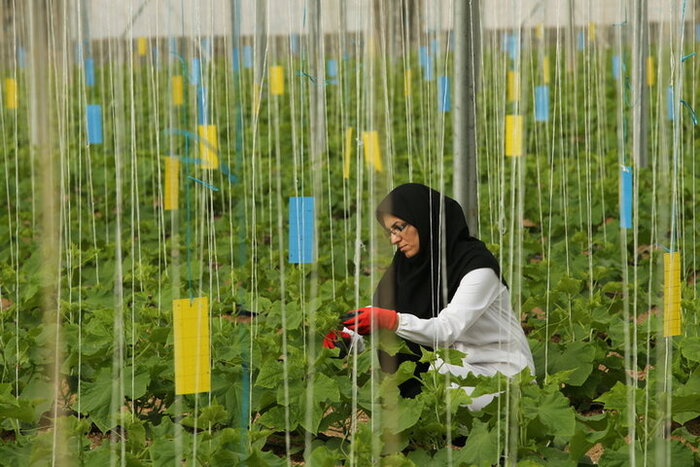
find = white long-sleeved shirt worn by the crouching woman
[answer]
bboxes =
[396,268,535,386]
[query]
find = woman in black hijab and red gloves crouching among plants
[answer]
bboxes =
[336,183,535,410]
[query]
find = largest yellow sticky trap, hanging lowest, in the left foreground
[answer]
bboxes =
[173,297,211,394]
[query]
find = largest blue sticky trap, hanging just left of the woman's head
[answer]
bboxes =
[289,196,314,264]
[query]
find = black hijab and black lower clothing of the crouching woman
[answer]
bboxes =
[373,183,505,397]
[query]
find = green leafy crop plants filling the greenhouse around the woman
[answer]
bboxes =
[0,44,700,466]
